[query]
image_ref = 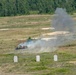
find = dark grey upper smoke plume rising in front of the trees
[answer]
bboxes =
[52,8,76,32]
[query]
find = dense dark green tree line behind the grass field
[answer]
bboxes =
[0,0,76,16]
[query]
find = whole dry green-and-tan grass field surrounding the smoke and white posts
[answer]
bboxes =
[0,15,76,75]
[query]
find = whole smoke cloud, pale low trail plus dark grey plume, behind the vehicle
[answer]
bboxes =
[16,8,76,53]
